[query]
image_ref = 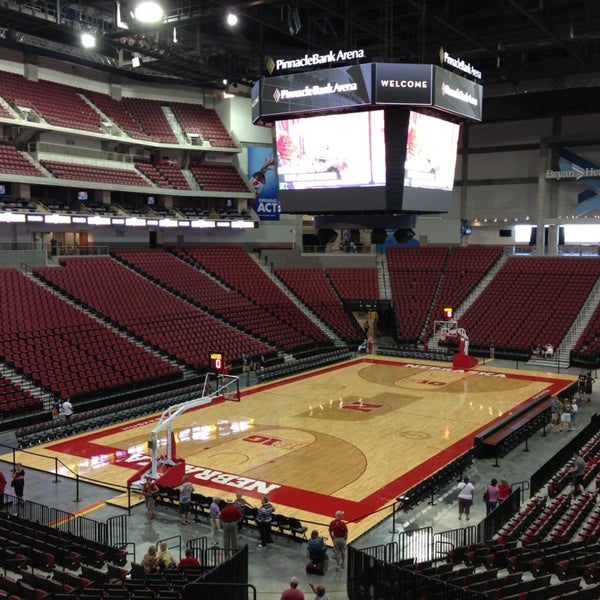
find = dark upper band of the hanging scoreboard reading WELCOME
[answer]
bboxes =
[252,63,483,123]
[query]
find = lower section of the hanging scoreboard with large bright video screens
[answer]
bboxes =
[275,108,460,214]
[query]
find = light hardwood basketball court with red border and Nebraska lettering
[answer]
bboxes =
[5,357,575,539]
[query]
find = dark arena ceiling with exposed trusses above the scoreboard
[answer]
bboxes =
[0,0,600,108]
